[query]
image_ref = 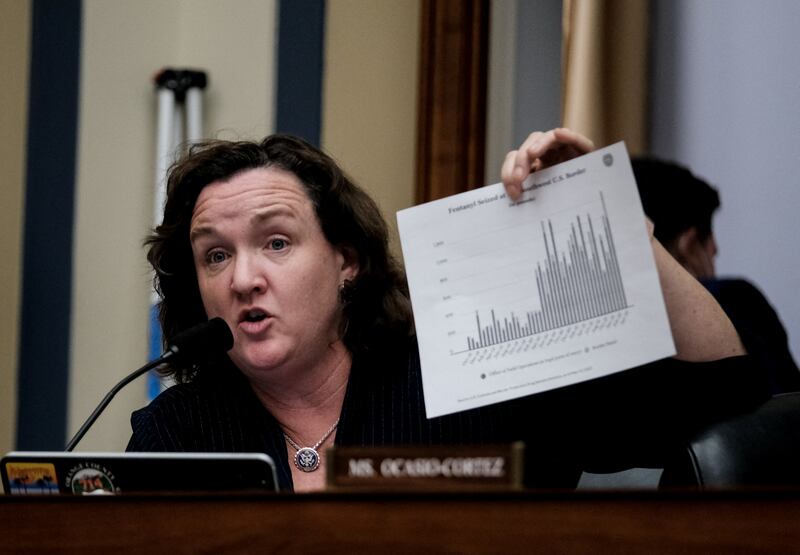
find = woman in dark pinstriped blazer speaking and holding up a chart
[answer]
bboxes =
[128,129,760,491]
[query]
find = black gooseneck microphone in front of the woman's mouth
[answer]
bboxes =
[64,318,233,452]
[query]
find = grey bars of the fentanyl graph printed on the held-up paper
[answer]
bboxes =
[466,192,628,354]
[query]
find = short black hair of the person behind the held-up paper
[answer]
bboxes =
[631,157,720,246]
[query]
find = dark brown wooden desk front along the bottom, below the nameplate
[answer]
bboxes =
[0,492,800,555]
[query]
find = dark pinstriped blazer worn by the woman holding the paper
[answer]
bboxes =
[127,341,766,490]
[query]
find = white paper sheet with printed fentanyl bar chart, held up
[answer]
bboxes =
[397,143,675,418]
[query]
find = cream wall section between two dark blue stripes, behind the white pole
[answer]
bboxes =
[68,0,276,450]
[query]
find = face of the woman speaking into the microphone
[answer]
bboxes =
[190,168,358,381]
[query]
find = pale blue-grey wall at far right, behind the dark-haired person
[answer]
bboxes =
[651,0,800,360]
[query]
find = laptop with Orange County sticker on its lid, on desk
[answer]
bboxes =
[0,451,278,495]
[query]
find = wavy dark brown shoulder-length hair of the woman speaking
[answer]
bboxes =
[145,134,413,381]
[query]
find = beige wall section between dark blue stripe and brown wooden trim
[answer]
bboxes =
[322,0,420,252]
